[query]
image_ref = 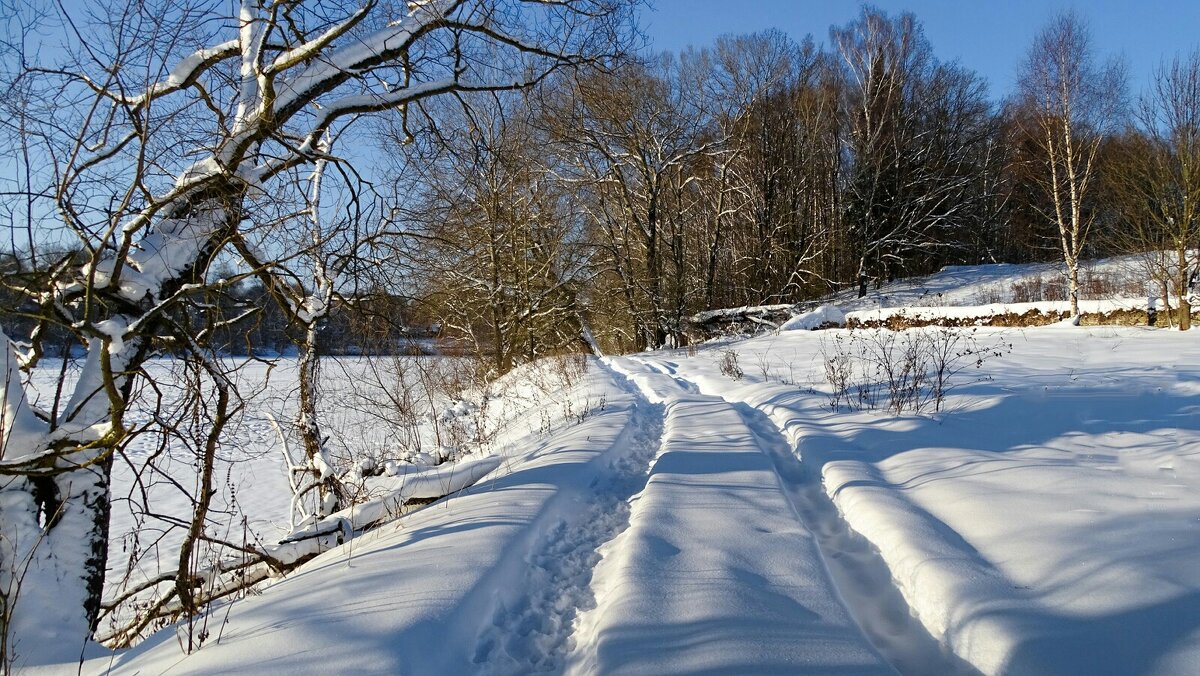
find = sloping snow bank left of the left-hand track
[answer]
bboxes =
[85,360,644,674]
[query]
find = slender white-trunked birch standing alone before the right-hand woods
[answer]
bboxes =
[1019,12,1126,322]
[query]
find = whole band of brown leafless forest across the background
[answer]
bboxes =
[5,6,1200,372]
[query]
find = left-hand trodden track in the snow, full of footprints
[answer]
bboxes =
[474,365,662,675]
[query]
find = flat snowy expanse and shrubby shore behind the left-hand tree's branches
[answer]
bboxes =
[18,357,580,635]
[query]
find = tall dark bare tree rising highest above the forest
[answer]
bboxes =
[832,7,992,295]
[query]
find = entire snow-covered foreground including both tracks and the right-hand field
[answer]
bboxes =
[30,260,1200,675]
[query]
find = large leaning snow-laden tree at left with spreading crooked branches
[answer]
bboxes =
[0,0,632,668]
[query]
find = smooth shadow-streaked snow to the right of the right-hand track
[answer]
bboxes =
[628,327,1200,674]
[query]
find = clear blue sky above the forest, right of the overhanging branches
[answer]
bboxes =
[642,0,1200,97]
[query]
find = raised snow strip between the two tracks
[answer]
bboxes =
[569,359,893,674]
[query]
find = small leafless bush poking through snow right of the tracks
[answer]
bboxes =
[821,327,1012,415]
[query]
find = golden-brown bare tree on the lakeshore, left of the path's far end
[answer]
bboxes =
[400,94,586,375]
